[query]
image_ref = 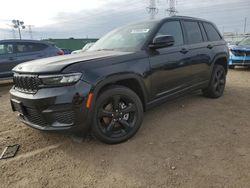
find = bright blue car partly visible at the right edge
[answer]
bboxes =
[229,37,250,69]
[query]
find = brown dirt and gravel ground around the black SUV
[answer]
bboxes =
[0,68,250,188]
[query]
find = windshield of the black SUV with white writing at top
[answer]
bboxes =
[88,22,156,51]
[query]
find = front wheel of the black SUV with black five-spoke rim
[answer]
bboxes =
[91,86,143,144]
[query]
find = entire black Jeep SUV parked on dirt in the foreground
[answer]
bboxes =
[10,16,229,144]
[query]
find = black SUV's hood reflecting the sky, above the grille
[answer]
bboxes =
[13,51,134,73]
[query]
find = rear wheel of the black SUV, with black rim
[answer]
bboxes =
[202,65,226,98]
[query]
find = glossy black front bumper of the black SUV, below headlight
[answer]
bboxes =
[10,80,91,132]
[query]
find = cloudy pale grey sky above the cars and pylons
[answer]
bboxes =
[0,0,250,40]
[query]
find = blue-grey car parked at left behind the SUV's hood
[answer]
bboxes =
[0,40,64,79]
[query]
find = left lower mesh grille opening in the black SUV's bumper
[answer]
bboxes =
[25,107,48,127]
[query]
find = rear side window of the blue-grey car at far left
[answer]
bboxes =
[17,43,47,53]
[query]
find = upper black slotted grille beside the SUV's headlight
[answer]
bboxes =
[13,73,41,93]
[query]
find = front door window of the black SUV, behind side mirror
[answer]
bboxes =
[156,21,183,46]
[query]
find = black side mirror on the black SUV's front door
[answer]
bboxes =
[149,35,174,49]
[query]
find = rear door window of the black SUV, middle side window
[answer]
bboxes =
[184,21,203,44]
